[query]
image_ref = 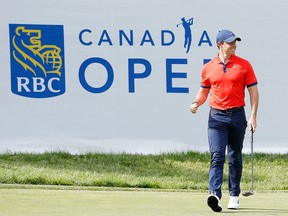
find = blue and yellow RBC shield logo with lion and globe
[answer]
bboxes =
[9,24,65,98]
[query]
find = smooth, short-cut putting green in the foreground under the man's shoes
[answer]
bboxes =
[0,188,288,216]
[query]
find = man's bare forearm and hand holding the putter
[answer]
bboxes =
[248,85,259,132]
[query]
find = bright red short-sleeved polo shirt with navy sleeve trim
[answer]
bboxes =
[201,55,257,110]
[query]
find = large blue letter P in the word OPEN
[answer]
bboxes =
[128,59,152,93]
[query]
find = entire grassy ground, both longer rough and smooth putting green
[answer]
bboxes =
[0,152,288,216]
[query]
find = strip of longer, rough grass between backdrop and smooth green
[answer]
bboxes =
[0,152,288,191]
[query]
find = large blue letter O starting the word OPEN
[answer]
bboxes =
[79,57,114,93]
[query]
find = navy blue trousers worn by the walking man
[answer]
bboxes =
[208,108,247,199]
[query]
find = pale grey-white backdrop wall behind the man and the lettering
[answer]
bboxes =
[0,0,288,154]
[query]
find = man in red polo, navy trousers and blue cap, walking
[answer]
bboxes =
[190,30,259,212]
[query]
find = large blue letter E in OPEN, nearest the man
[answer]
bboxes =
[166,59,189,93]
